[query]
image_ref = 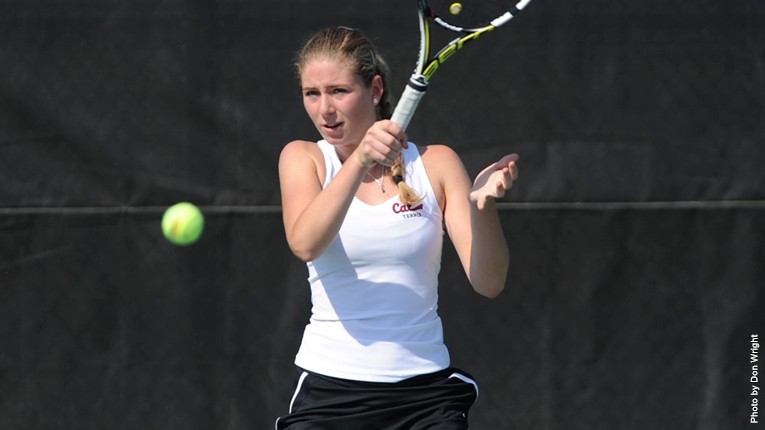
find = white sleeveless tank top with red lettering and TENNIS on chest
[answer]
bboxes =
[295,141,449,382]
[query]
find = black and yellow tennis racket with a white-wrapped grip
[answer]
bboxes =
[391,0,531,130]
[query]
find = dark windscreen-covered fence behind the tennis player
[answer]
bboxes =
[0,0,765,429]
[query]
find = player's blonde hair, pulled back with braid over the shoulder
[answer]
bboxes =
[295,27,422,205]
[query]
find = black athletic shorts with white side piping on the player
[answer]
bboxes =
[276,368,478,430]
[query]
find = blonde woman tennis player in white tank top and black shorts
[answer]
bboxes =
[276,27,518,430]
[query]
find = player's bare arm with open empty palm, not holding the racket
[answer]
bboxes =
[423,145,518,298]
